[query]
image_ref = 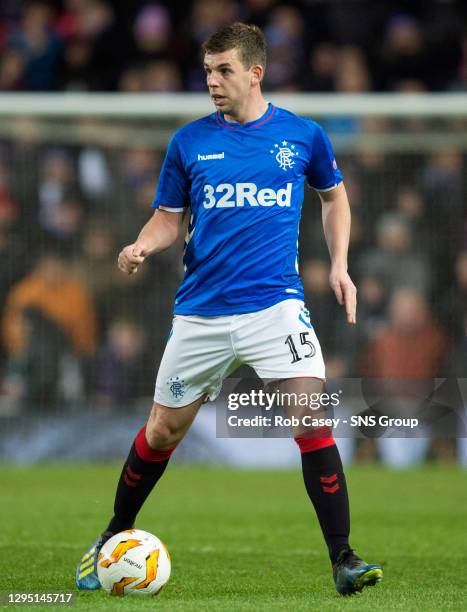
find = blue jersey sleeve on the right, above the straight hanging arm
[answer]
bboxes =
[306,122,343,191]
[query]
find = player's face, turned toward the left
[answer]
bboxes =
[204,49,257,117]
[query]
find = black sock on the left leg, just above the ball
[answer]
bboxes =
[106,444,169,533]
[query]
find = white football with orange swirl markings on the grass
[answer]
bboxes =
[97,529,171,597]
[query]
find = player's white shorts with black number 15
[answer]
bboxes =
[154,299,325,408]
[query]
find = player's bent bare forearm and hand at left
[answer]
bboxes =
[118,209,183,274]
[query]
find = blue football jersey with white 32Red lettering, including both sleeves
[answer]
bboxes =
[152,104,342,316]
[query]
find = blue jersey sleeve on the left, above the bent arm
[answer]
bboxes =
[152,134,189,212]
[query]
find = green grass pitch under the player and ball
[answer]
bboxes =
[0,465,467,612]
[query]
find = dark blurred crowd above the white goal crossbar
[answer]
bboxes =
[0,0,467,92]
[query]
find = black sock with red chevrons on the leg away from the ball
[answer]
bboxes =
[302,444,350,563]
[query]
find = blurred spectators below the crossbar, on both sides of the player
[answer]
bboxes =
[0,130,467,418]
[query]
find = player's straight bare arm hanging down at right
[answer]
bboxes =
[319,183,357,325]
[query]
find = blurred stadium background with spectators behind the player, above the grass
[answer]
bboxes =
[0,0,467,466]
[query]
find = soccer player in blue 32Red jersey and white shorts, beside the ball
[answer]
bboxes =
[76,23,382,595]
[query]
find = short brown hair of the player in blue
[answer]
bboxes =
[203,21,266,68]
